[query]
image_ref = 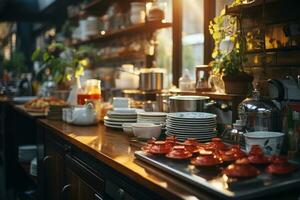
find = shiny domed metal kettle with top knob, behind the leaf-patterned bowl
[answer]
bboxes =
[238,89,281,131]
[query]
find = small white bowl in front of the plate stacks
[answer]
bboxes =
[132,123,161,139]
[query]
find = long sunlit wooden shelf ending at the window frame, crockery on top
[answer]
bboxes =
[73,21,172,46]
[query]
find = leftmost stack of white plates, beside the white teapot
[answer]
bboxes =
[104,111,137,129]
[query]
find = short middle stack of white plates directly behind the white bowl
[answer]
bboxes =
[137,112,167,125]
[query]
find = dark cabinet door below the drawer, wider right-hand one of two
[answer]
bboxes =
[63,155,104,200]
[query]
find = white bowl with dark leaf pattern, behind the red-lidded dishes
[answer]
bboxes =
[244,131,284,155]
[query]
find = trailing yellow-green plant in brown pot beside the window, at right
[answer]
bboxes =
[209,0,253,94]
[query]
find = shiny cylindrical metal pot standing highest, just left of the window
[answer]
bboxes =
[140,68,164,91]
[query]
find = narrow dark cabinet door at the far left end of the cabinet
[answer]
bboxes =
[43,138,63,200]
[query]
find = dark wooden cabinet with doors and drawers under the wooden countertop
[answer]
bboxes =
[37,123,161,200]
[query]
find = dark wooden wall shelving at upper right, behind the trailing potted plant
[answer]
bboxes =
[225,0,300,80]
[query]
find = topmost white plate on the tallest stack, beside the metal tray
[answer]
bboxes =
[167,112,217,120]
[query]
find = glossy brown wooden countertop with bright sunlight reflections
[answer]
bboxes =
[39,119,216,200]
